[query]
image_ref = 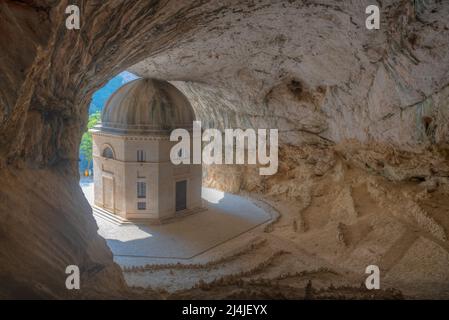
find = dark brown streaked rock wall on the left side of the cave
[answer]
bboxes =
[0,1,210,298]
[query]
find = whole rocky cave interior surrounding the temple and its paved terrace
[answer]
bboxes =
[0,0,449,299]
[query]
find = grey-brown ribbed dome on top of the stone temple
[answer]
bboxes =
[99,78,195,134]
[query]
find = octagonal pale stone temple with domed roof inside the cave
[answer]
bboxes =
[91,78,202,223]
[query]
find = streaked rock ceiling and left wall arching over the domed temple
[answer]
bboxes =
[0,0,449,297]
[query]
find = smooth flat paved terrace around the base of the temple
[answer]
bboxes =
[81,181,272,266]
